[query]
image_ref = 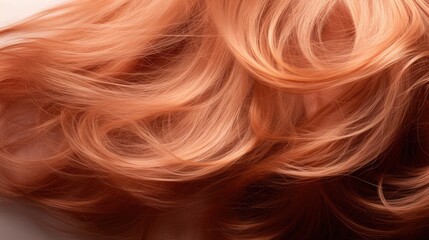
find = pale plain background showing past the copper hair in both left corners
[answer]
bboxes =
[0,0,85,240]
